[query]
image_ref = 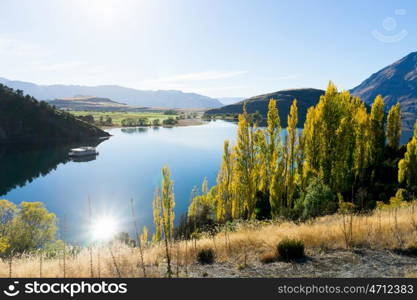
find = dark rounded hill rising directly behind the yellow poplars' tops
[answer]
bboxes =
[205,88,324,127]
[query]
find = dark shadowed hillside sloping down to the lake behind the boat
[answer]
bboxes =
[0,84,109,144]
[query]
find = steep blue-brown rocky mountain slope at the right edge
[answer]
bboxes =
[351,52,417,130]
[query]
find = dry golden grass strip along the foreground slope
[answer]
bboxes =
[0,203,417,278]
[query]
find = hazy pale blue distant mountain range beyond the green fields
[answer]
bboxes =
[0,78,222,108]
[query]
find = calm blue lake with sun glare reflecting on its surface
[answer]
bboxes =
[0,121,236,243]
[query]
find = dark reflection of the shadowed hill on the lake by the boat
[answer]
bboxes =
[0,140,103,196]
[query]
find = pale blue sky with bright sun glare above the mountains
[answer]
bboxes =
[0,0,417,98]
